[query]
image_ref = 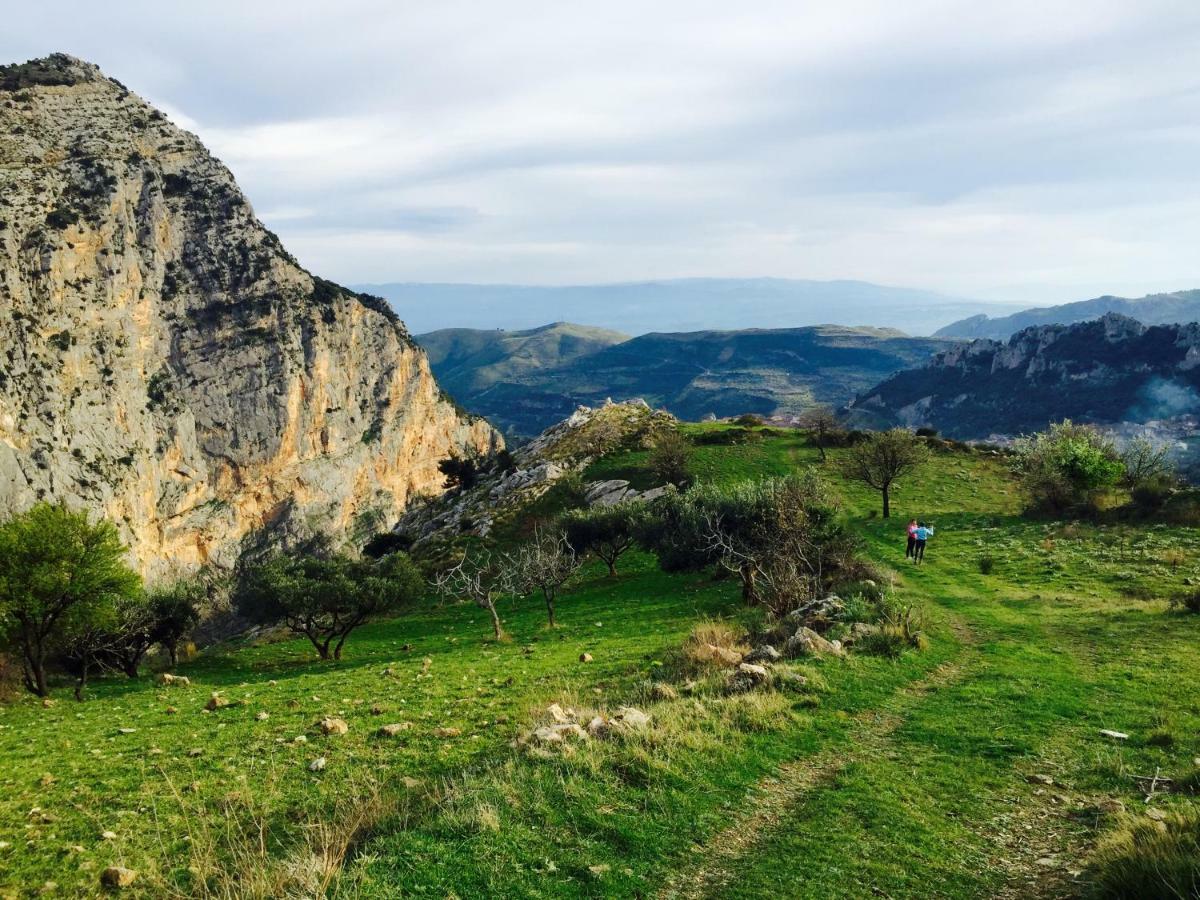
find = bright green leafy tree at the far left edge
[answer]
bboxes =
[0,503,142,697]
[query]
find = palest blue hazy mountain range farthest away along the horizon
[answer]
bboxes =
[360,278,1020,335]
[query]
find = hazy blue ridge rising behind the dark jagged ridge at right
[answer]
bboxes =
[937,290,1200,341]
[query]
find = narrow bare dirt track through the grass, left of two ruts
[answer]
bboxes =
[658,657,973,900]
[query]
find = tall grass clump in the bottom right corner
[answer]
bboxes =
[1090,810,1200,900]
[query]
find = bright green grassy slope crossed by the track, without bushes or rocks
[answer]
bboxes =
[0,434,1200,898]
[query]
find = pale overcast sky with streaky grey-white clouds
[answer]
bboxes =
[0,0,1200,301]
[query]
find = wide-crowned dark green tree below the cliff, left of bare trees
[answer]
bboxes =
[234,553,424,660]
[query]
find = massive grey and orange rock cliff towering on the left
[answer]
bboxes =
[0,56,499,575]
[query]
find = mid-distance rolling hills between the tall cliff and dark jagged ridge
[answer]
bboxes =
[416,323,953,436]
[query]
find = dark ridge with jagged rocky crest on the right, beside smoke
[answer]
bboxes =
[851,313,1200,438]
